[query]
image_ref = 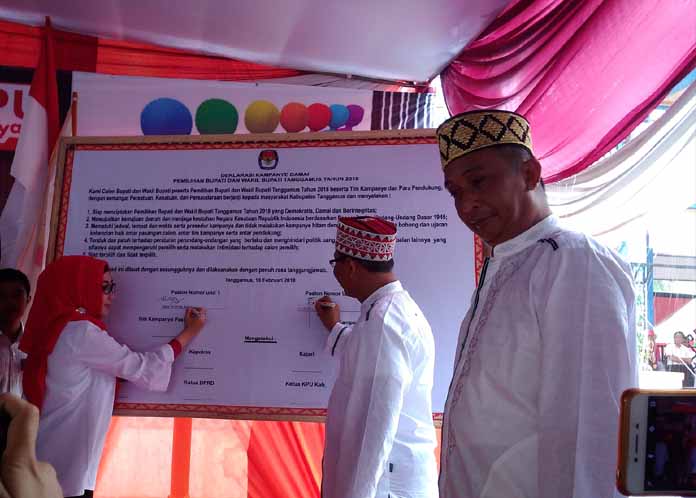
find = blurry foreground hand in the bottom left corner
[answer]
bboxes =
[0,393,63,498]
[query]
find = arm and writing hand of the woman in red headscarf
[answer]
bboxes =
[70,308,206,391]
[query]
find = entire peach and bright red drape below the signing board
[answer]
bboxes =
[94,417,442,498]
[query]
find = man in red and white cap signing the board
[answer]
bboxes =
[316,217,437,498]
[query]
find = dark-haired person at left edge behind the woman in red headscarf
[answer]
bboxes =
[0,268,31,397]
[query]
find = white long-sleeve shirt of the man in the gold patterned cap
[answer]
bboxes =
[440,216,637,498]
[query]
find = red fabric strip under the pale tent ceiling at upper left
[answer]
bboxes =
[0,21,303,81]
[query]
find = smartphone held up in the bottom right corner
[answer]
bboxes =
[616,389,696,496]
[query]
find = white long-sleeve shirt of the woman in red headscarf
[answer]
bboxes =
[36,321,174,496]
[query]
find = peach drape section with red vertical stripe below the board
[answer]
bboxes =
[94,417,253,498]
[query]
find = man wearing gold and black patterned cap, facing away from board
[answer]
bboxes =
[437,111,636,498]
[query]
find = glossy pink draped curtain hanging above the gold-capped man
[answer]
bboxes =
[442,0,696,182]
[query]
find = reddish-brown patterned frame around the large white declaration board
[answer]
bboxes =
[46,129,484,425]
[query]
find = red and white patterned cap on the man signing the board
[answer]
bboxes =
[336,216,396,261]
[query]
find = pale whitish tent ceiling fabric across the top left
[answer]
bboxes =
[0,0,509,82]
